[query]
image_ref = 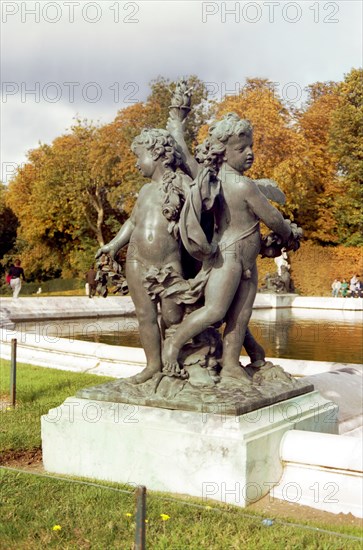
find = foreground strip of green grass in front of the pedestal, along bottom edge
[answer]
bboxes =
[0,469,361,550]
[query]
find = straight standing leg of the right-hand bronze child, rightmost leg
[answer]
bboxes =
[221,266,257,378]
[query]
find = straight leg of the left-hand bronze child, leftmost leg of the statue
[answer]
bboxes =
[126,261,162,383]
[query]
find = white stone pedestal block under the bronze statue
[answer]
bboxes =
[42,391,337,506]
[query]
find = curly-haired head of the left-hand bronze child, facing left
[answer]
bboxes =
[131,128,182,177]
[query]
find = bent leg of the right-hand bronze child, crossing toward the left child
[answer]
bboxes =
[163,258,242,370]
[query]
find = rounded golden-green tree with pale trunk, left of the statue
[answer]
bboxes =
[5,121,120,276]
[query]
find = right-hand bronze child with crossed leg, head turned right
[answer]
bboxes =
[162,113,295,382]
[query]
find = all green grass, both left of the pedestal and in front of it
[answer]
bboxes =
[0,361,362,550]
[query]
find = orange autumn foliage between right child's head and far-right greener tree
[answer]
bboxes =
[199,78,356,244]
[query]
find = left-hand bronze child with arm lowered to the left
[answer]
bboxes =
[96,129,189,383]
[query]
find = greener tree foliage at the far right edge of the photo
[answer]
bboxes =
[329,69,363,246]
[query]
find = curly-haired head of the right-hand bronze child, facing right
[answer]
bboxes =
[196,113,253,173]
